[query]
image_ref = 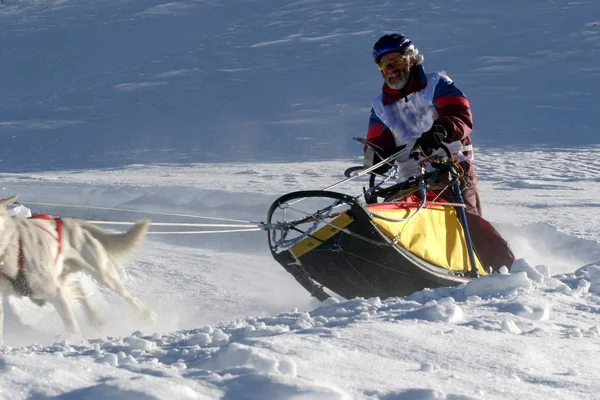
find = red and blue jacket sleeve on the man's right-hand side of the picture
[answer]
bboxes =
[433,75,473,142]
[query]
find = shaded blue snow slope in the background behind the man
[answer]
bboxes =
[0,0,600,171]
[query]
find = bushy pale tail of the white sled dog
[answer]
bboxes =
[82,219,150,262]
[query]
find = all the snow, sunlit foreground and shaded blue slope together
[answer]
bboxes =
[0,0,600,400]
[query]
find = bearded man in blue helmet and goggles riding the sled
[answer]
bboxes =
[365,33,514,269]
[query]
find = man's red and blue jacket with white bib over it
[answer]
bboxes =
[367,65,473,160]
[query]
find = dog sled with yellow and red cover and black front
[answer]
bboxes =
[264,139,510,301]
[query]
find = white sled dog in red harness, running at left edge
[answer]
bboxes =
[0,196,155,344]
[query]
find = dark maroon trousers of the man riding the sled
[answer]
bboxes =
[436,161,515,271]
